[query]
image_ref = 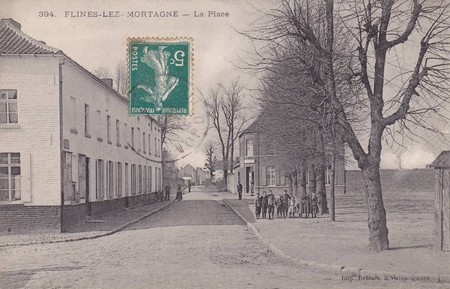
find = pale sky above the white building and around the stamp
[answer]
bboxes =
[0,0,450,168]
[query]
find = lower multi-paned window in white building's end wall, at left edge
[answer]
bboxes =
[0,153,20,201]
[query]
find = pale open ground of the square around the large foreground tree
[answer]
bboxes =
[223,192,450,282]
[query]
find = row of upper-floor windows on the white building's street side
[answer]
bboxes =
[70,97,161,157]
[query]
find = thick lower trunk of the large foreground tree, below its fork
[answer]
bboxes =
[361,161,389,251]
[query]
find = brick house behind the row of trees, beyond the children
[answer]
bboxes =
[235,118,345,194]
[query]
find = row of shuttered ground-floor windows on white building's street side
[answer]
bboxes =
[95,159,161,200]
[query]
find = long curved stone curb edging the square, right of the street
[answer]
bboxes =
[222,199,450,283]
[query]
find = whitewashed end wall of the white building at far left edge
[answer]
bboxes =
[0,55,61,206]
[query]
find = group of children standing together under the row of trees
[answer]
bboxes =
[255,190,319,220]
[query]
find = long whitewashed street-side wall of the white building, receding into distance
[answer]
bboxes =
[63,62,161,205]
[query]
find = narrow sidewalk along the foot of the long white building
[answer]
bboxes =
[0,199,173,247]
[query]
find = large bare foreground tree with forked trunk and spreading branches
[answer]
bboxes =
[246,0,449,251]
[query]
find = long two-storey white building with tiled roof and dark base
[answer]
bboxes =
[0,19,161,233]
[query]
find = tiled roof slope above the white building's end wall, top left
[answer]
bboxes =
[0,19,62,54]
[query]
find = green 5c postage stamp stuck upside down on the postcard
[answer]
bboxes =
[128,38,192,115]
